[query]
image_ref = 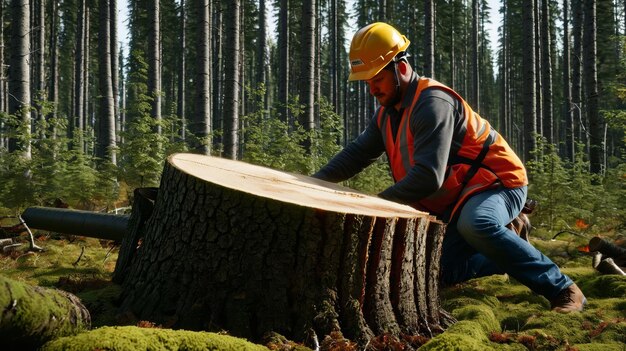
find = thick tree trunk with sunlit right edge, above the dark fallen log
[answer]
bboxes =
[96,0,117,164]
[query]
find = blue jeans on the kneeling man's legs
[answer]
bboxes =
[441,187,573,299]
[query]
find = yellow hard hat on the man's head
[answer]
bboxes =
[348,22,411,80]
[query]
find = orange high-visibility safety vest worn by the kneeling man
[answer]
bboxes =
[377,78,528,220]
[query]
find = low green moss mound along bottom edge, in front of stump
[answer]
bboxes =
[42,327,268,351]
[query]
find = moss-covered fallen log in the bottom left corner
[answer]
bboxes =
[0,276,91,350]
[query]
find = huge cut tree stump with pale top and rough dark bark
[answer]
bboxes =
[115,154,449,345]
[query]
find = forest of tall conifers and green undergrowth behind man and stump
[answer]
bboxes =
[0,0,626,262]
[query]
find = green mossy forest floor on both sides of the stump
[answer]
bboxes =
[0,227,626,351]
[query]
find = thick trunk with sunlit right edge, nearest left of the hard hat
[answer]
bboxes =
[299,0,317,153]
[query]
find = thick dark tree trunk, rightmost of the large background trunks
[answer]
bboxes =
[583,0,604,174]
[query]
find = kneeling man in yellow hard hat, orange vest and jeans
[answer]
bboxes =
[313,22,586,313]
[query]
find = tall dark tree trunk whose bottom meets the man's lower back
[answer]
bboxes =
[522,0,537,161]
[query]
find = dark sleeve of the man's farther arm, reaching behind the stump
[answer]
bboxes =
[312,113,385,183]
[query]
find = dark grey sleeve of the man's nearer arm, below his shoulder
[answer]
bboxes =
[379,89,459,205]
